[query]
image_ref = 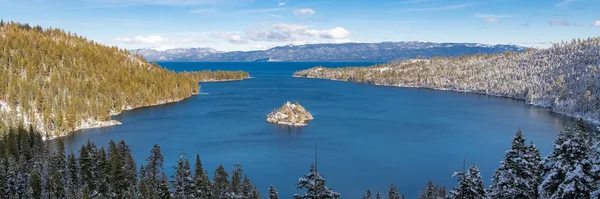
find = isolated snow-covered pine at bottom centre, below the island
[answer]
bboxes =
[294,164,340,199]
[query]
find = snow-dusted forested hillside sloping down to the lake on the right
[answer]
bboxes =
[294,38,600,122]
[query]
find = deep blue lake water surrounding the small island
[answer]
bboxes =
[61,63,569,198]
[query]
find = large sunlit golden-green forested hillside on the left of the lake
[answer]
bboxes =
[0,22,199,137]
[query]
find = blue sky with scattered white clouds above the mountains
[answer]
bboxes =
[0,0,600,51]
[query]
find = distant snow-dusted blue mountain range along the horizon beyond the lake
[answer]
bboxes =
[131,41,527,62]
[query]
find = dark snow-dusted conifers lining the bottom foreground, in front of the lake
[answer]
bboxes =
[0,120,600,199]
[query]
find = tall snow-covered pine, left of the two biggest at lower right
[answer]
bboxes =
[489,130,541,199]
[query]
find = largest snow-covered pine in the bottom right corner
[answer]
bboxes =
[539,121,598,199]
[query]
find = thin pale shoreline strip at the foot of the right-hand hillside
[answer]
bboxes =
[292,75,600,125]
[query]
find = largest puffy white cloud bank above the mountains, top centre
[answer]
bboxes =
[246,23,351,42]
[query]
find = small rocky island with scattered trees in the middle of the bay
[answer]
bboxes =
[267,102,313,126]
